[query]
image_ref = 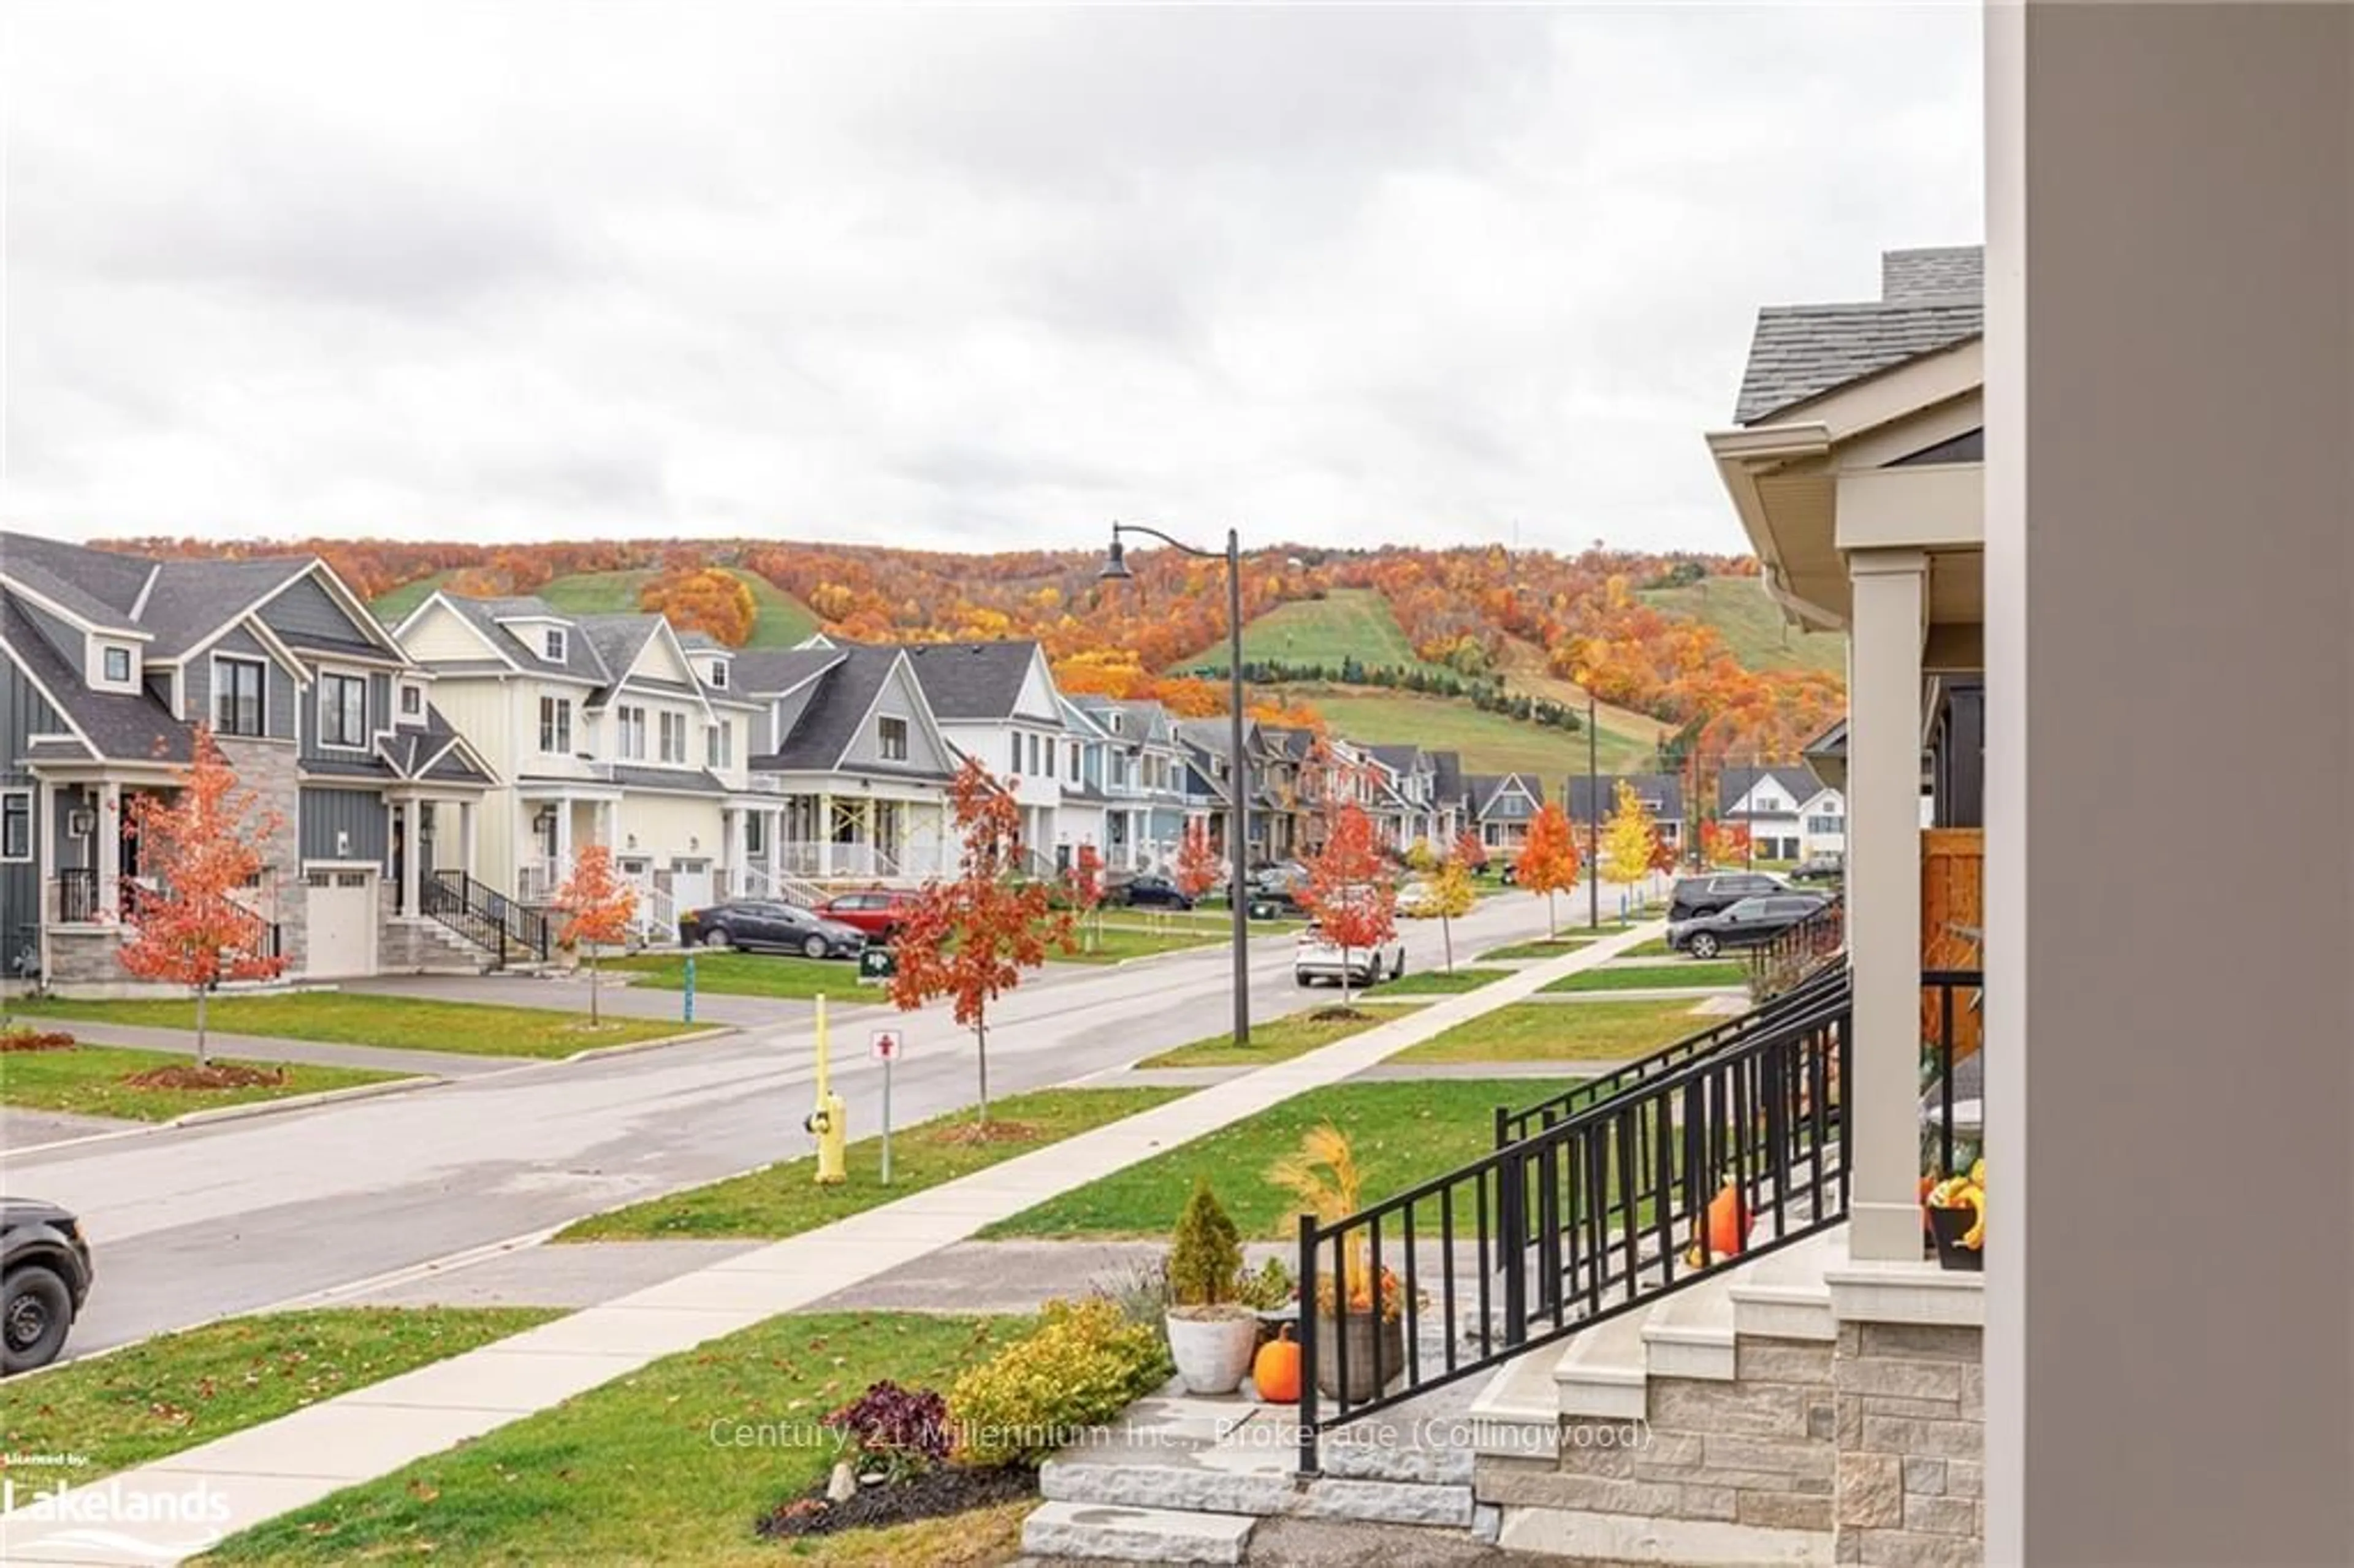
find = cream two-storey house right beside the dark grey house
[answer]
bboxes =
[395,593,777,939]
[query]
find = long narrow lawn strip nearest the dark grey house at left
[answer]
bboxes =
[9,991,706,1057]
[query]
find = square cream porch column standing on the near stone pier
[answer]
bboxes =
[1841,551,1928,1262]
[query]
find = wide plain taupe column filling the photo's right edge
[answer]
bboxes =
[1984,5,2354,1563]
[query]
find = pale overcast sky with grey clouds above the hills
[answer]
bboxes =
[0,0,1982,551]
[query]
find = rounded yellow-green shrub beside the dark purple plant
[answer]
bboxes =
[949,1297,1170,1464]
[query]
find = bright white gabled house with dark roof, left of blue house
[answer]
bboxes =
[902,641,1068,876]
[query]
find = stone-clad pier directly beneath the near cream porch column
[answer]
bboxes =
[1832,1323,1987,1568]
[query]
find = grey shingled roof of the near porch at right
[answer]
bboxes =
[1732,245,1987,424]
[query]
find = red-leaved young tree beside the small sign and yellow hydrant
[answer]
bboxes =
[890,756,1071,1135]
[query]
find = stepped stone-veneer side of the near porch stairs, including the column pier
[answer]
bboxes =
[1476,1323,1987,1568]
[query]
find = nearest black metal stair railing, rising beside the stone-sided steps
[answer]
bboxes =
[1300,986,1850,1474]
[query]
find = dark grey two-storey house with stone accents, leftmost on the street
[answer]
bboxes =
[0,535,497,986]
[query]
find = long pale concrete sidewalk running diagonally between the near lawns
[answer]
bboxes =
[0,927,1655,1563]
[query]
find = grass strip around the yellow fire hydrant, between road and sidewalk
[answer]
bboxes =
[555,1087,1186,1241]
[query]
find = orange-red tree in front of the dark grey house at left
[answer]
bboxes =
[118,725,287,1067]
